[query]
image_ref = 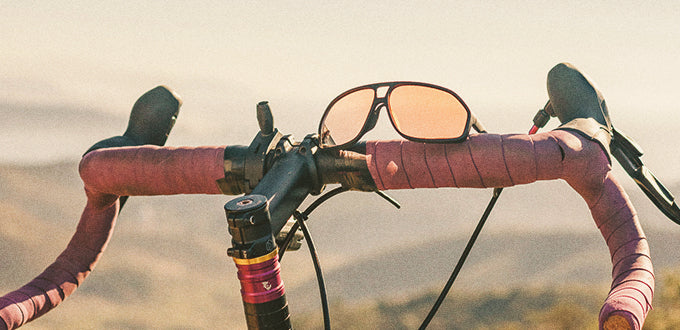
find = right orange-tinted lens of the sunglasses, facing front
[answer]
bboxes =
[388,85,469,140]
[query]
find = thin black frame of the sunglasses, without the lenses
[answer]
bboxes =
[318,81,473,149]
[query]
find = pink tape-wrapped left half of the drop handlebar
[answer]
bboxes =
[0,145,224,329]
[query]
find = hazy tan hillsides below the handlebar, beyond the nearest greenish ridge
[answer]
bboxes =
[0,163,680,328]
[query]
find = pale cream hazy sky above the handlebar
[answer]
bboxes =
[0,0,680,179]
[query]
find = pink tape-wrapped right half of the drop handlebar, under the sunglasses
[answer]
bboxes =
[366,130,654,329]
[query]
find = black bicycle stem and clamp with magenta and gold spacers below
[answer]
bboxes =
[217,102,376,329]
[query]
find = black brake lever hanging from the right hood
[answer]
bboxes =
[611,128,680,225]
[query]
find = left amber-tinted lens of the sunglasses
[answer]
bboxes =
[319,88,375,146]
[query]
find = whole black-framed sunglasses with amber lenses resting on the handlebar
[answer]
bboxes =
[319,81,472,148]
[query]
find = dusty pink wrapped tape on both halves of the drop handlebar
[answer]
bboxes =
[0,131,654,329]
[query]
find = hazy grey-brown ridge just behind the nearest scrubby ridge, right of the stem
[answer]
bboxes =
[283,228,680,306]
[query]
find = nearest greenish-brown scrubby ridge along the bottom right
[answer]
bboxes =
[293,270,680,330]
